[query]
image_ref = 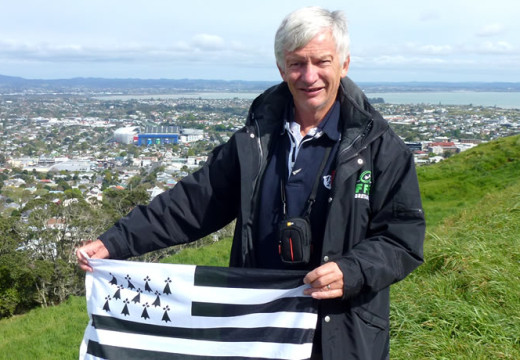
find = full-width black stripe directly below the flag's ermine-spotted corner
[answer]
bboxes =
[92,315,314,344]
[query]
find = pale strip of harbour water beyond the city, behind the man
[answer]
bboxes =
[96,91,520,109]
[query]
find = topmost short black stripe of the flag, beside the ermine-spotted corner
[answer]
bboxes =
[194,266,307,289]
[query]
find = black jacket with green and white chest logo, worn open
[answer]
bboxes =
[100,78,425,360]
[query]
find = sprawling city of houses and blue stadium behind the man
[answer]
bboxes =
[0,94,520,214]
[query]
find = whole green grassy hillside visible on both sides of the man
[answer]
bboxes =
[0,136,520,359]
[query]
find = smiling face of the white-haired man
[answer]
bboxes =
[279,31,350,121]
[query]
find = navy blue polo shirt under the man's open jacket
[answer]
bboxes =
[255,100,341,269]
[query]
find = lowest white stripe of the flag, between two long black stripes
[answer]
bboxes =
[91,330,312,360]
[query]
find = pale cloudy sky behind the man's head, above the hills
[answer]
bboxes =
[0,0,520,82]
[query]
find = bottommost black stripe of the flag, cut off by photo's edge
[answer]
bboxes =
[87,340,304,360]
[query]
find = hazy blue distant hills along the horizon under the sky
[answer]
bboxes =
[0,75,520,94]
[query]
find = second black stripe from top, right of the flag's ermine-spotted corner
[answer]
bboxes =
[191,297,316,317]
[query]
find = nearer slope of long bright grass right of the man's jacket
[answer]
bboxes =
[391,183,520,359]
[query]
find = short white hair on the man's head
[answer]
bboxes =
[274,6,350,70]
